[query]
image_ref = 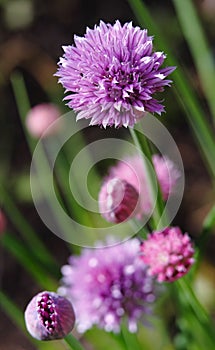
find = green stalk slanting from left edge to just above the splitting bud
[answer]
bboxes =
[1,232,57,290]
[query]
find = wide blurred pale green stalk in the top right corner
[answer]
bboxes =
[172,0,215,122]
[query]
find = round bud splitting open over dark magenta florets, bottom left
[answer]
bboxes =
[25,291,75,340]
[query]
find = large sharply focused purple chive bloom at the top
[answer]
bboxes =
[56,21,175,127]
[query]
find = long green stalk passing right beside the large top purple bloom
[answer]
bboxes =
[128,0,215,177]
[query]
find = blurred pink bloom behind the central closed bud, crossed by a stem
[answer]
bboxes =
[99,155,180,221]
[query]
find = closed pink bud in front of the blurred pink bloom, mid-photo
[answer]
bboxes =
[99,178,139,223]
